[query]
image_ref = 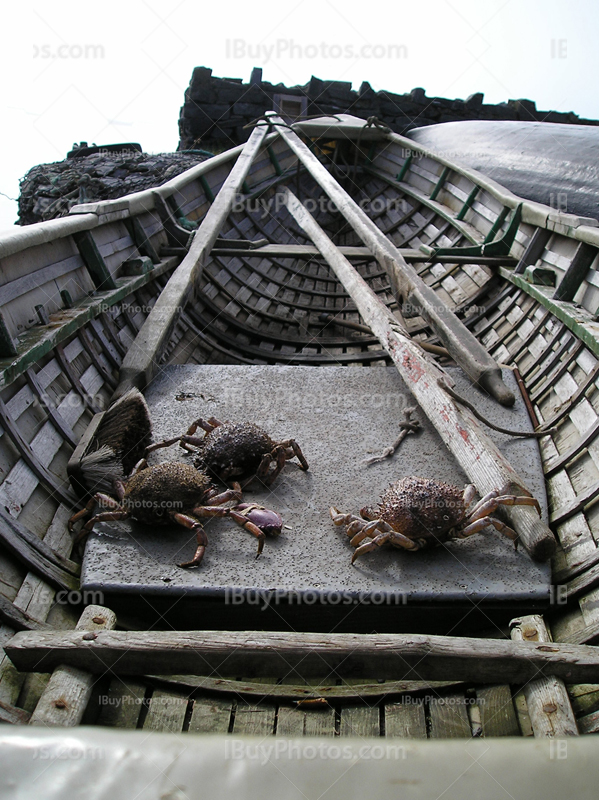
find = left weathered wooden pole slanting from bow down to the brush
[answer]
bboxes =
[117,127,266,395]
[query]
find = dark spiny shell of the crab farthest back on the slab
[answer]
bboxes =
[195,422,276,480]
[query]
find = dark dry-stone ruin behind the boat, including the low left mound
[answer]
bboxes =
[18,67,599,225]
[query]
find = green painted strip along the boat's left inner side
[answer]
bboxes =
[0,256,179,388]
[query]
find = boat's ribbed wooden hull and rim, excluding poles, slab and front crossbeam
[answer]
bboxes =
[0,111,599,738]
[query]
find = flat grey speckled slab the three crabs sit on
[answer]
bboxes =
[82,366,550,627]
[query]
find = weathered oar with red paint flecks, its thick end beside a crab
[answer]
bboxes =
[286,189,556,561]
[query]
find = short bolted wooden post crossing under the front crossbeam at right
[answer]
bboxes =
[510,615,583,737]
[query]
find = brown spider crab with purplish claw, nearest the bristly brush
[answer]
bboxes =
[69,459,283,567]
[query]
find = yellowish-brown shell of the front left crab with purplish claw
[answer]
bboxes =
[123,462,211,525]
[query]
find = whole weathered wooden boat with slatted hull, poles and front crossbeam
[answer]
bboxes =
[0,115,599,764]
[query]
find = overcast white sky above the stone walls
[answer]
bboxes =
[0,0,599,230]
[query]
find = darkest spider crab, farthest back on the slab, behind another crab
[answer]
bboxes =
[159,417,308,486]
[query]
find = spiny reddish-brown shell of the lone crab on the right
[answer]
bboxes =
[362,477,468,547]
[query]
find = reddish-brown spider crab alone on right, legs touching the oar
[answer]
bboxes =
[330,478,541,564]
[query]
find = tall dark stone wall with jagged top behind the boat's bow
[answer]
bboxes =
[178,67,599,150]
